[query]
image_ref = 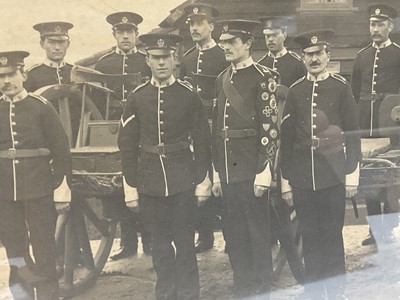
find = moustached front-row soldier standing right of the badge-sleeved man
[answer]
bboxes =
[281,29,361,299]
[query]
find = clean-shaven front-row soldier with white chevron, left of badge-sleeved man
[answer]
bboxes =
[118,34,211,300]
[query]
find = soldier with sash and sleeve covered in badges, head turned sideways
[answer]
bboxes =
[213,20,279,299]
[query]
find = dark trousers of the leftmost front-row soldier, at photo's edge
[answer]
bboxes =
[0,197,59,300]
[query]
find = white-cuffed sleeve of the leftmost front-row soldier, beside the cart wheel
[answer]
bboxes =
[42,103,72,202]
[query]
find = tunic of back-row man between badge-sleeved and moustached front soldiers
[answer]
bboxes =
[258,48,307,87]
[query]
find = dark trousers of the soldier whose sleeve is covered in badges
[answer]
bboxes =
[222,181,272,299]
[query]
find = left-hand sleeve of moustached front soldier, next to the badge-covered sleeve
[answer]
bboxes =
[280,89,296,179]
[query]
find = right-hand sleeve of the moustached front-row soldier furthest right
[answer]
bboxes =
[340,83,361,174]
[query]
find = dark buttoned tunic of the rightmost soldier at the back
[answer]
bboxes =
[351,40,400,137]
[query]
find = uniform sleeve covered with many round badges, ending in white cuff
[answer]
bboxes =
[254,76,279,186]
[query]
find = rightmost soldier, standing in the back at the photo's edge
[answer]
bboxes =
[351,4,400,245]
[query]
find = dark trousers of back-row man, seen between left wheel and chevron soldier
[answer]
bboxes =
[102,197,151,250]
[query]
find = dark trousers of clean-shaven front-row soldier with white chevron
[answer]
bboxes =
[139,189,200,300]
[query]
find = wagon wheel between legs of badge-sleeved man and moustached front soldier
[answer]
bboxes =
[270,195,304,284]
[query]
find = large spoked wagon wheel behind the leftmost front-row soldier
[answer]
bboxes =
[37,85,116,298]
